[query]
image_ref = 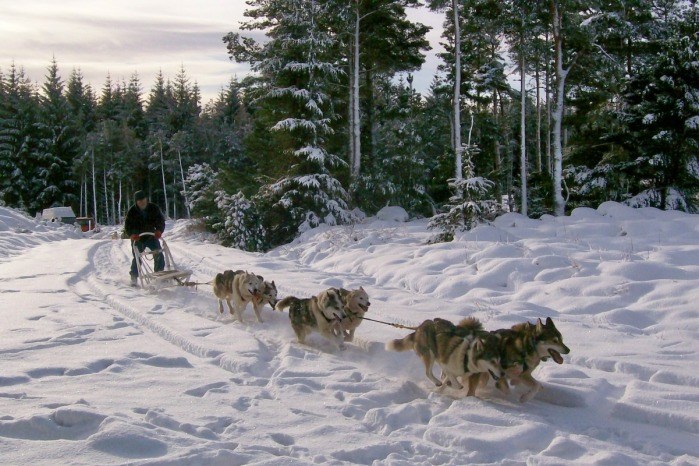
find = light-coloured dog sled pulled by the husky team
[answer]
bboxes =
[131,232,192,290]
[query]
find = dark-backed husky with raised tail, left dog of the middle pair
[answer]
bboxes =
[274,288,346,348]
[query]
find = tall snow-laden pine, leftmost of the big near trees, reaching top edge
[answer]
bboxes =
[225,0,351,245]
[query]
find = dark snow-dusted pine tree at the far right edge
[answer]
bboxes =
[622,9,699,212]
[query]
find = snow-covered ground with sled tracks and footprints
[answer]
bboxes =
[0,203,699,466]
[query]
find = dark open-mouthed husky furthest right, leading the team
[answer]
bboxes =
[485,317,570,403]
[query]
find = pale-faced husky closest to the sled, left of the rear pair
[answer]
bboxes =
[213,270,262,322]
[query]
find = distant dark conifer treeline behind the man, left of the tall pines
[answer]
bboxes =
[0,60,245,224]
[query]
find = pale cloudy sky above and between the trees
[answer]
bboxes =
[0,0,443,103]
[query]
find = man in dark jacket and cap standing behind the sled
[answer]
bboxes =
[124,191,165,285]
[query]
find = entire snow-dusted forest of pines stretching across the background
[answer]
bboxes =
[0,0,699,250]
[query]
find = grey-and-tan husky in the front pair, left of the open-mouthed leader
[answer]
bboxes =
[386,318,502,396]
